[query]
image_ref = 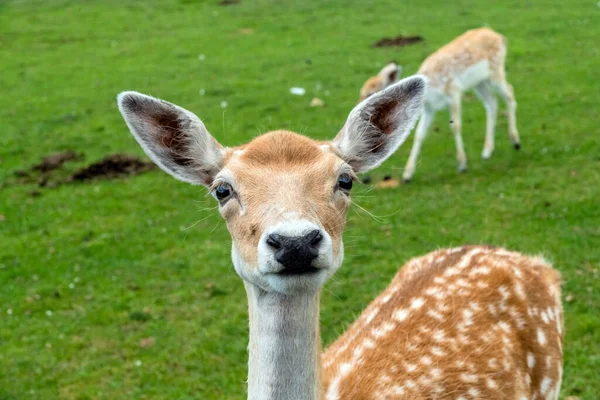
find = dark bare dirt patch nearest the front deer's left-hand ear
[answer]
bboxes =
[68,154,154,182]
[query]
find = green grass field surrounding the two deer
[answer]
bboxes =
[0,0,600,400]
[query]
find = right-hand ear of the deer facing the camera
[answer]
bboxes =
[332,75,426,172]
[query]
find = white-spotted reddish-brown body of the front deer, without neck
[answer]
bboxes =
[322,246,564,400]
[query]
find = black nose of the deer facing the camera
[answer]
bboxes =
[267,229,323,274]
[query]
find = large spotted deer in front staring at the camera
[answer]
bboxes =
[118,76,564,400]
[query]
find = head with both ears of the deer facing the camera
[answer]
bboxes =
[118,76,425,294]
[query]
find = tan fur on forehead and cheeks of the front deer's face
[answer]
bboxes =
[223,131,349,263]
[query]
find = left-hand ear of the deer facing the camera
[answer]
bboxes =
[117,92,224,186]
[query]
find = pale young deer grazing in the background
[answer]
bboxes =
[360,28,521,183]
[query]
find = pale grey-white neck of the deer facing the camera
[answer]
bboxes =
[245,283,321,400]
